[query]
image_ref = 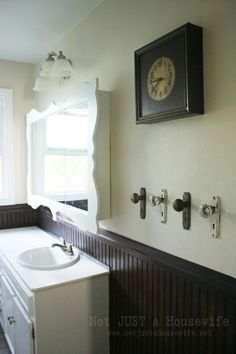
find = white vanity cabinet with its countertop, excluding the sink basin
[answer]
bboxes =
[0,228,109,354]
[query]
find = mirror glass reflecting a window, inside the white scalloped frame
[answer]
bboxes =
[32,102,88,210]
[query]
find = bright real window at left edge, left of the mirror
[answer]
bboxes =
[0,88,14,205]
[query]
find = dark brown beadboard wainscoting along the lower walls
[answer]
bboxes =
[0,205,236,354]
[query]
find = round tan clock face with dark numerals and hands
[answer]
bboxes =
[147,57,175,101]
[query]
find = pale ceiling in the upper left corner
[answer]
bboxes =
[0,0,102,63]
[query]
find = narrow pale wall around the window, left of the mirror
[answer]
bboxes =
[0,60,35,204]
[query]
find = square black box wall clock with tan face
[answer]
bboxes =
[135,23,204,124]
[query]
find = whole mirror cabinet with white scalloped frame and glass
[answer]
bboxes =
[26,79,110,233]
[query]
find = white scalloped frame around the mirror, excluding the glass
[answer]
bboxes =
[26,79,110,233]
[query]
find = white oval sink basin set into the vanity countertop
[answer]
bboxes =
[16,247,80,270]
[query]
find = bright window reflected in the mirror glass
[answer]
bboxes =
[44,109,88,198]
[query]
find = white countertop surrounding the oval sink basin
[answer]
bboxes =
[0,226,109,292]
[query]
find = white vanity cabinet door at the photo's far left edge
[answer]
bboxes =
[1,276,15,354]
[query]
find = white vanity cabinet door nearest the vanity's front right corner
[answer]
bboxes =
[13,297,34,354]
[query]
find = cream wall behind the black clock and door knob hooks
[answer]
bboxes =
[35,0,236,276]
